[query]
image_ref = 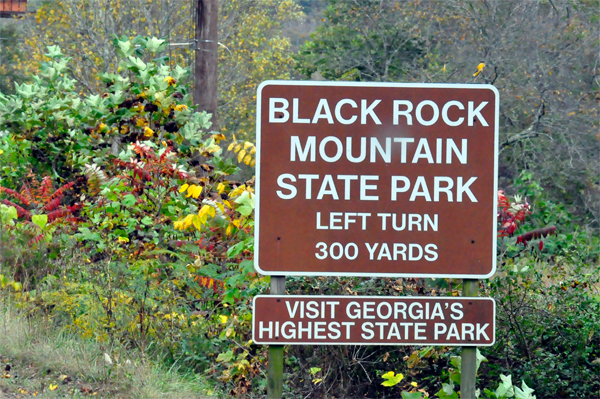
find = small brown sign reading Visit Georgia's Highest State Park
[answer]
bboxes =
[252,295,496,346]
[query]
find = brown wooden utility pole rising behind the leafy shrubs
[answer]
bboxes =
[193,0,219,126]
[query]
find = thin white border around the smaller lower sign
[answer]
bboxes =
[252,295,496,347]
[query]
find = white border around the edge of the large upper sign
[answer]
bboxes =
[254,80,500,280]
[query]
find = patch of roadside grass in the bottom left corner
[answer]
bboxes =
[0,297,220,399]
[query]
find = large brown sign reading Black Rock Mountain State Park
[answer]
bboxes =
[255,81,499,278]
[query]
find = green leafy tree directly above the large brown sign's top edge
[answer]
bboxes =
[297,0,423,82]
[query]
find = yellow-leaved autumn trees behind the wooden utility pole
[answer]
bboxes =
[16,0,303,141]
